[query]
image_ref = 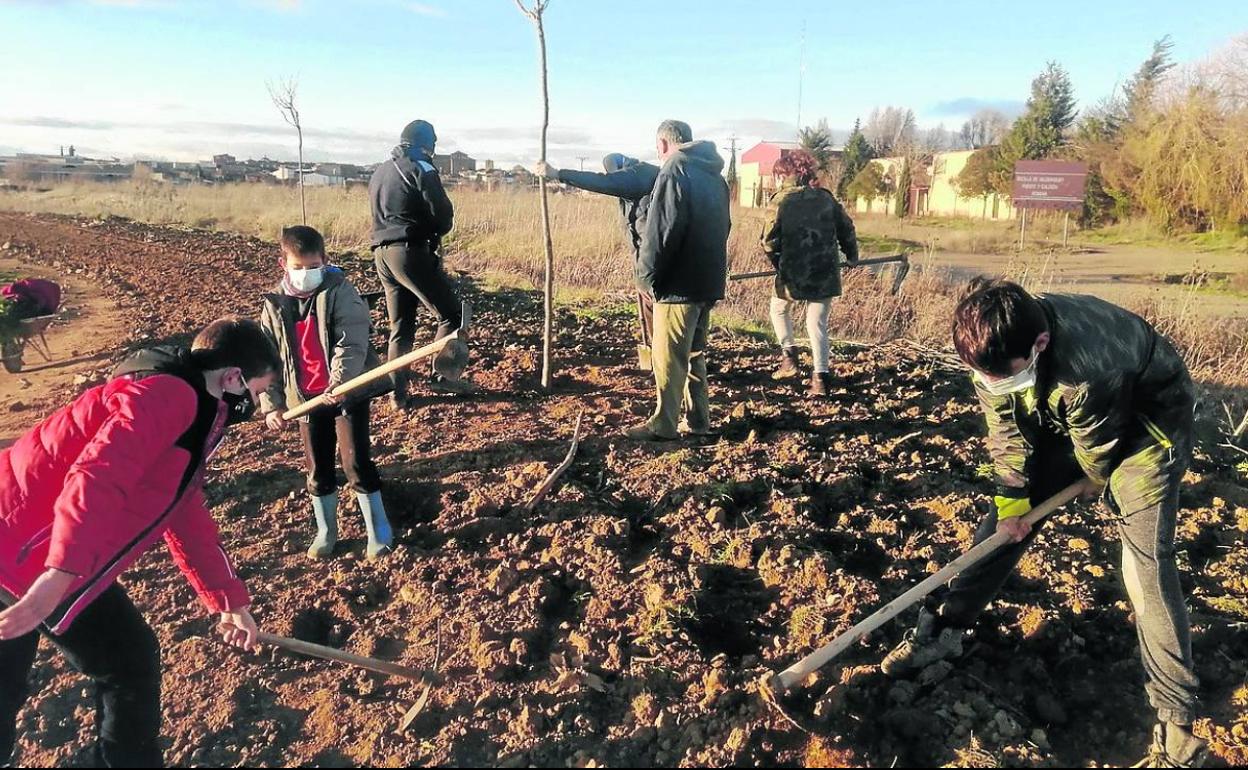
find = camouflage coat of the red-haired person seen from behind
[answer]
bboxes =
[763,186,859,301]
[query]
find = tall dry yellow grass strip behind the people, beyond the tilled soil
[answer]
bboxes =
[0,182,1248,388]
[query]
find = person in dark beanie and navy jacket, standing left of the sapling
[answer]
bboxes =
[368,120,467,407]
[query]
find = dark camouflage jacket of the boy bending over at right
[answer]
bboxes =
[976,295,1196,513]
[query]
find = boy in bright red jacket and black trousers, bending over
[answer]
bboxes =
[0,318,281,768]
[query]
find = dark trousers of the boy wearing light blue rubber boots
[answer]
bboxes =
[300,401,382,497]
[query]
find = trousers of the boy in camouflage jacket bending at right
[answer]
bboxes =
[938,429,1199,725]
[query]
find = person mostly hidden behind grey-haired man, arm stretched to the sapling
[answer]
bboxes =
[535,152,659,372]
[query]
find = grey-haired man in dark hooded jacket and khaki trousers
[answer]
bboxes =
[624,120,731,441]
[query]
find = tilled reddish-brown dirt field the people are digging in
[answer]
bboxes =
[0,208,1248,766]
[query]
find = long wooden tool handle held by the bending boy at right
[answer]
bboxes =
[771,479,1088,693]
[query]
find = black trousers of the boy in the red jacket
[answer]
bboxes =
[0,583,162,768]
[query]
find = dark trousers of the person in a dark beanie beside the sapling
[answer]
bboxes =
[373,242,463,397]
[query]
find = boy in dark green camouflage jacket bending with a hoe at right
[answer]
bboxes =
[882,278,1206,768]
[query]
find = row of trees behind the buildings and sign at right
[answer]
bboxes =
[801,35,1248,231]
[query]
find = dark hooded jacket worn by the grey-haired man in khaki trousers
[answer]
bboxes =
[636,141,731,303]
